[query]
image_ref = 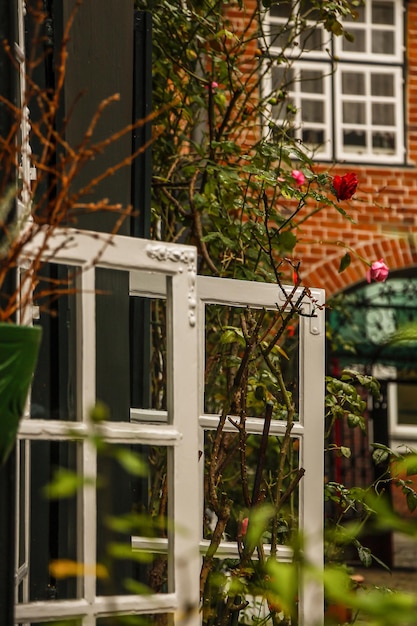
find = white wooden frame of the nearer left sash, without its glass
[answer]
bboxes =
[15,230,200,626]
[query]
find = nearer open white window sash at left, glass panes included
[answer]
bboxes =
[16,231,200,626]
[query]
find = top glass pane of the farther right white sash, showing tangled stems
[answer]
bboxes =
[204,305,299,419]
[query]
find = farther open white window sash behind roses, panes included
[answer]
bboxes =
[197,276,324,626]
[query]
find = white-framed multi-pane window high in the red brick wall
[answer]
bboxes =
[265,0,405,163]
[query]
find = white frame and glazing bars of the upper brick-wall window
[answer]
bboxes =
[264,0,406,164]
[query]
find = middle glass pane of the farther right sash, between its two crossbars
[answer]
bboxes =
[203,434,302,545]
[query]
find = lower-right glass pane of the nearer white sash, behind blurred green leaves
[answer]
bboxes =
[97,445,168,595]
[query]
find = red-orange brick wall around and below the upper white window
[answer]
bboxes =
[226,0,417,296]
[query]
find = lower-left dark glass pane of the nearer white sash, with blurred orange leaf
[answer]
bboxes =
[22,441,78,601]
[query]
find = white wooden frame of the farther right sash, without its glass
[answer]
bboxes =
[197,276,325,626]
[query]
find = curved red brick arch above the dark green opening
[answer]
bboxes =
[301,234,417,298]
